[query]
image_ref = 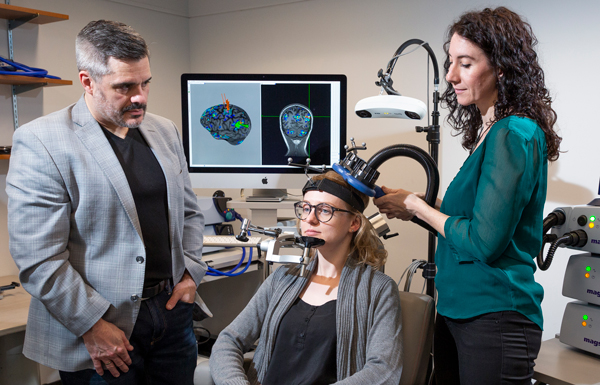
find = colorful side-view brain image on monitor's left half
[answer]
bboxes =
[200,101,252,146]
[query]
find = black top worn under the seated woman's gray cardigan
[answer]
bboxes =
[262,298,337,385]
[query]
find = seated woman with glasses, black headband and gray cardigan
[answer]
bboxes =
[210,171,402,385]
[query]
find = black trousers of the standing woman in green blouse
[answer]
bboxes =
[433,311,542,385]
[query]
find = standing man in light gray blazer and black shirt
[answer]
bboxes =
[6,20,206,385]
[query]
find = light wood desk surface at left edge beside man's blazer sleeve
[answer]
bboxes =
[0,275,31,336]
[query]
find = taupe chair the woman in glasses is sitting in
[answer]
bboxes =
[194,291,435,385]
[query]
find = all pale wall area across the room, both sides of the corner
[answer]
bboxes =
[0,0,600,339]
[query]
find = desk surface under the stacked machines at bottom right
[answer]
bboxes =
[533,338,600,385]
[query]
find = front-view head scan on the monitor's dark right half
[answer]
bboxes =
[279,103,313,156]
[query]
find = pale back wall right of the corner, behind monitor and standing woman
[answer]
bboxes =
[190,0,600,339]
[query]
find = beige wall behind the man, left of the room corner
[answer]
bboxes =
[0,0,189,275]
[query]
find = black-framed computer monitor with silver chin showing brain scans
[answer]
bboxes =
[181,74,347,200]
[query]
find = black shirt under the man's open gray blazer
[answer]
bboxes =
[99,128,172,287]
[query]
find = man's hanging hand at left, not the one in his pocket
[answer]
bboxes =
[83,318,133,377]
